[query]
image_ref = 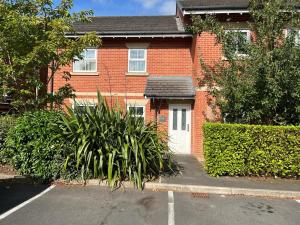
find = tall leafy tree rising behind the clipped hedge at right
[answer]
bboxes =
[190,0,300,125]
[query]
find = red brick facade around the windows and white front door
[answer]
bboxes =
[54,12,247,160]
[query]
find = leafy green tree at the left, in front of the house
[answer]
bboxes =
[0,0,101,111]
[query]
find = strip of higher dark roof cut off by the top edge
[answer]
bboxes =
[177,0,250,10]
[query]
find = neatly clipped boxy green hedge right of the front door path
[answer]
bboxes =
[204,123,300,177]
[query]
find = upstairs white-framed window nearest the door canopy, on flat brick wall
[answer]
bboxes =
[128,49,147,73]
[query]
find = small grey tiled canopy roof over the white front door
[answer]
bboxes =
[145,76,195,99]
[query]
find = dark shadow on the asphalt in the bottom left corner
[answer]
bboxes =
[0,178,49,215]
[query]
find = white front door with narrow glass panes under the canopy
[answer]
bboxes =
[169,104,191,154]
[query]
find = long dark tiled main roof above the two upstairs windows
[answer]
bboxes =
[74,16,185,34]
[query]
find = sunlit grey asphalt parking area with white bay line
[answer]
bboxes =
[0,186,300,225]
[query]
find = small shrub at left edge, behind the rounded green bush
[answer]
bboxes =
[0,115,16,163]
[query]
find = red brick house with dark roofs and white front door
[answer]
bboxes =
[54,0,262,160]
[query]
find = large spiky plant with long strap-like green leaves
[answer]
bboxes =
[60,93,171,188]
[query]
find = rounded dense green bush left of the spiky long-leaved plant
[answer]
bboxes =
[4,111,69,181]
